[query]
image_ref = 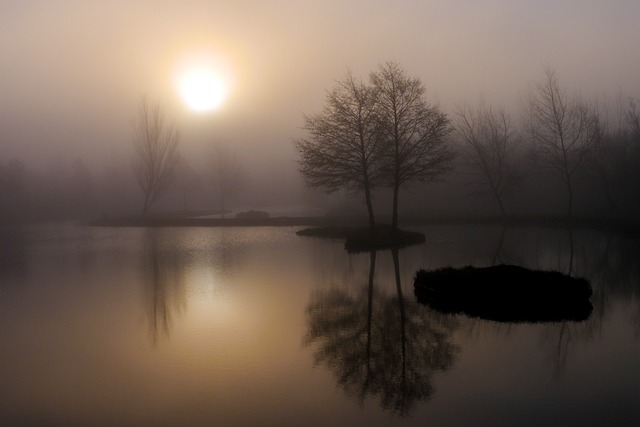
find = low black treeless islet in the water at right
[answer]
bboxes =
[414,264,593,323]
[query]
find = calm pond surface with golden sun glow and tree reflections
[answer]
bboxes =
[0,224,640,426]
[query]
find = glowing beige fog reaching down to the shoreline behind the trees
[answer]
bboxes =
[0,0,640,224]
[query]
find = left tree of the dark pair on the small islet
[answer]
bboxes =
[294,71,380,229]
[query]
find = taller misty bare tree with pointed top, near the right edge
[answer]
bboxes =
[527,66,597,218]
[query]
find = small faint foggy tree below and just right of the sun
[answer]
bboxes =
[211,143,246,218]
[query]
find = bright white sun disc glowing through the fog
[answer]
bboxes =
[178,67,228,112]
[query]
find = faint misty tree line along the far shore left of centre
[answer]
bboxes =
[0,97,245,223]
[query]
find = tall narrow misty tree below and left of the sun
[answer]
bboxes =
[133,98,180,216]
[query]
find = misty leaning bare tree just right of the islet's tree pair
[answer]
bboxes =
[454,102,521,216]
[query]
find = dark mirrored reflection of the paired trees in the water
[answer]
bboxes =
[304,250,459,416]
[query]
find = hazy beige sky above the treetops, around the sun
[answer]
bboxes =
[0,0,640,176]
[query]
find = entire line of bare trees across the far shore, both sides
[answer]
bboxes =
[0,62,640,228]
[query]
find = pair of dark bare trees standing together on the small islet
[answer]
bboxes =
[294,62,453,228]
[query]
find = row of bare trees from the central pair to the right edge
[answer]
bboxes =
[293,62,640,229]
